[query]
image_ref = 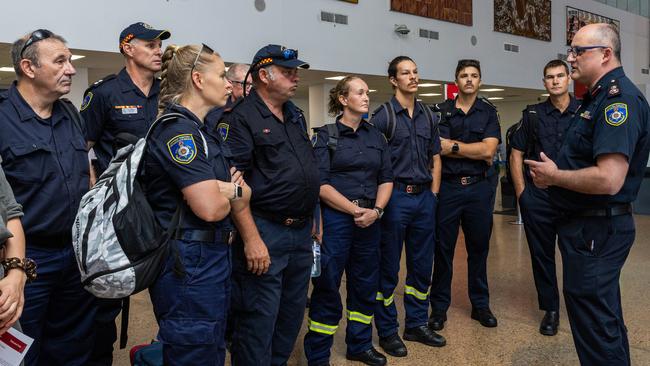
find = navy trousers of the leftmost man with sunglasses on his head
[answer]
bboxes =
[20,242,97,366]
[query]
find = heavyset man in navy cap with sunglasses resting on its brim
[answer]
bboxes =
[222,45,320,365]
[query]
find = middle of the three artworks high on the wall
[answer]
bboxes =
[494,0,551,42]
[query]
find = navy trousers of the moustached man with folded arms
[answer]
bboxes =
[431,178,493,313]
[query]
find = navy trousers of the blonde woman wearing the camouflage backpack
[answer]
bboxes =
[149,230,231,366]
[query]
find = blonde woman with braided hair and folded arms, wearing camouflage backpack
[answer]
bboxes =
[141,45,250,365]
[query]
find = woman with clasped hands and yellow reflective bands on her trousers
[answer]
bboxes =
[305,76,393,365]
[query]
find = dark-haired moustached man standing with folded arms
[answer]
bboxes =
[429,60,501,330]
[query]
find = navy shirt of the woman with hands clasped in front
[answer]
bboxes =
[314,117,393,200]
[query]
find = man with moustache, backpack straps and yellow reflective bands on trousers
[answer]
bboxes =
[371,56,446,357]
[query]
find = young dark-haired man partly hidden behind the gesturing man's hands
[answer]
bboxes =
[510,60,580,336]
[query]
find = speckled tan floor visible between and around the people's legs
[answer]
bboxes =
[115,215,650,366]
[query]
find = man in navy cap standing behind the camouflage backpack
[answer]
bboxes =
[80,22,171,365]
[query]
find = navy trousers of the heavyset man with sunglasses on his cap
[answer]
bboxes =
[231,216,313,366]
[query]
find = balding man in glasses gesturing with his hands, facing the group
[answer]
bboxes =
[524,23,650,365]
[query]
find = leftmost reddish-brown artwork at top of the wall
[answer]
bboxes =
[390,0,472,26]
